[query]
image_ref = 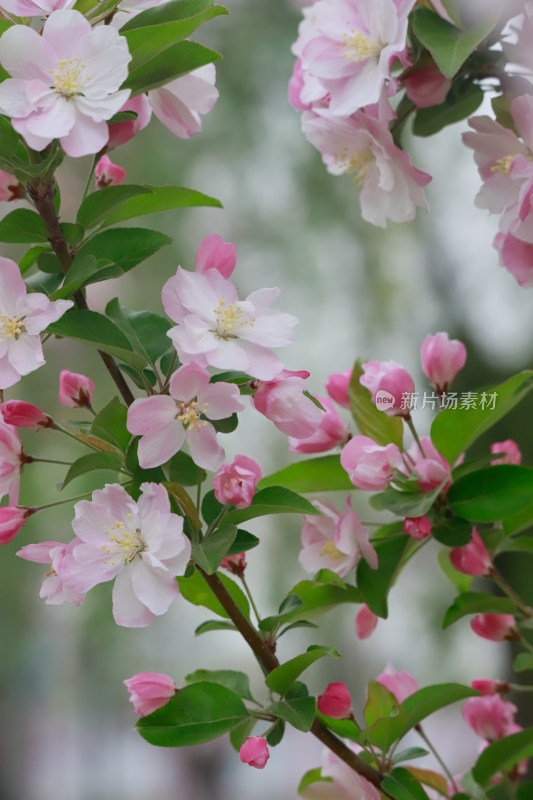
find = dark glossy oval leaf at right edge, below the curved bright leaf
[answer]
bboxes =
[448,464,533,522]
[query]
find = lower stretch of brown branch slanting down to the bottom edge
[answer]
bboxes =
[196,565,389,797]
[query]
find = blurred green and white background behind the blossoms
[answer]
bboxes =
[0,0,533,800]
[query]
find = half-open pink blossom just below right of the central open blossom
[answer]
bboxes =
[251,369,324,439]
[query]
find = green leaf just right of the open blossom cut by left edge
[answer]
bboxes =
[46,310,146,369]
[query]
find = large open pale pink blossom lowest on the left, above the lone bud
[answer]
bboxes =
[57,483,191,628]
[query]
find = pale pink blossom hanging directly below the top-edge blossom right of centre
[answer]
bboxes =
[302,109,431,228]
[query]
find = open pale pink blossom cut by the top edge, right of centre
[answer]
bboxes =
[292,0,415,116]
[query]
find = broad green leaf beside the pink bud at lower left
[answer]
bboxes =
[136,682,248,747]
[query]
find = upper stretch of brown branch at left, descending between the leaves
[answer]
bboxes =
[26,178,135,406]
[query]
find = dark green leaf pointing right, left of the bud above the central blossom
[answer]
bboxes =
[78,228,172,280]
